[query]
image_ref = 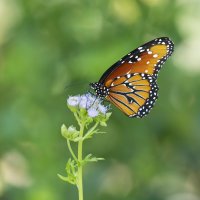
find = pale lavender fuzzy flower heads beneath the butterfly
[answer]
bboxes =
[67,93,108,118]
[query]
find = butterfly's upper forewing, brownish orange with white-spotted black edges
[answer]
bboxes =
[99,37,174,87]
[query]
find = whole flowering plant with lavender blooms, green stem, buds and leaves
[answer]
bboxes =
[58,93,111,191]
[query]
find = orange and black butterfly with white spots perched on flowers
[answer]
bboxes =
[90,37,174,118]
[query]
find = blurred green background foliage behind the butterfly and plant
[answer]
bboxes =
[0,0,200,200]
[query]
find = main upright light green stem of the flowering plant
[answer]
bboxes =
[77,123,84,200]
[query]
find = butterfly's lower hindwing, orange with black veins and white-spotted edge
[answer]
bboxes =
[106,73,158,117]
